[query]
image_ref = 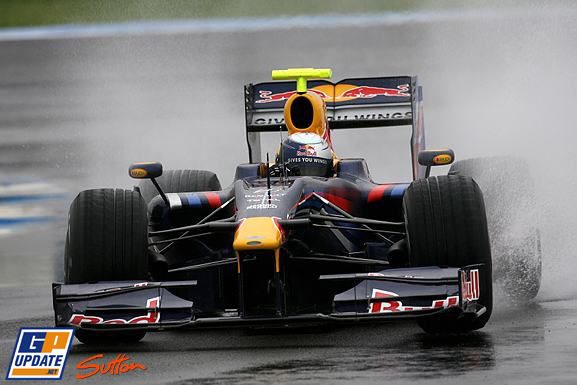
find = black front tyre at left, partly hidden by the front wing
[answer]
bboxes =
[64,189,148,344]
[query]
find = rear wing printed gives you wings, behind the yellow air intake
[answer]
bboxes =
[244,76,425,179]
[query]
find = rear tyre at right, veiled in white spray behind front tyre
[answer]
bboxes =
[449,157,542,301]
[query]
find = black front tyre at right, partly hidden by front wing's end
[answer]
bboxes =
[403,175,493,333]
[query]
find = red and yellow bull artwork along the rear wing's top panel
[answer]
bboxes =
[255,84,411,103]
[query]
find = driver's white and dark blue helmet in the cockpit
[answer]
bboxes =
[276,132,334,177]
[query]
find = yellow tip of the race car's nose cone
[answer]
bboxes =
[232,217,282,251]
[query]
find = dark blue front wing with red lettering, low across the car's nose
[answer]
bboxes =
[52,265,486,330]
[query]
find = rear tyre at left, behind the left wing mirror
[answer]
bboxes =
[138,170,221,203]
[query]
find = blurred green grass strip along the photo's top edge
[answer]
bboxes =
[0,0,552,27]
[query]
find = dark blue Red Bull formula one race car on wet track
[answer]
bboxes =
[53,69,532,343]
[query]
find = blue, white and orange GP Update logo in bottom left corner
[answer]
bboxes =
[6,328,74,380]
